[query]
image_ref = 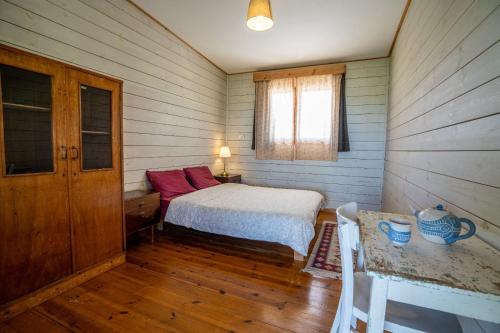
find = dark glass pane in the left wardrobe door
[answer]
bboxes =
[0,65,54,175]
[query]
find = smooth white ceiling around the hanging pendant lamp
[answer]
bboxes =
[133,0,406,73]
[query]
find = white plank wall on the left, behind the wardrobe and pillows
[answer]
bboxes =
[0,0,227,190]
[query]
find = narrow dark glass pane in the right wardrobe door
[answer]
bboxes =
[80,85,113,170]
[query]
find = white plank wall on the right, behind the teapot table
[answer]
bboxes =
[383,0,500,247]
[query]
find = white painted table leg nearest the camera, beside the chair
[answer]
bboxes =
[367,277,389,333]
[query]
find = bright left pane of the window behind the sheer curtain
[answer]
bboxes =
[269,79,294,143]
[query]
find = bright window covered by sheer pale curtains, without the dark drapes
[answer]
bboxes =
[256,74,341,161]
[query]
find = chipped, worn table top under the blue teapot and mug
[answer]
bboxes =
[358,210,500,300]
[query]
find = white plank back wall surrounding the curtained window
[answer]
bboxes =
[226,59,388,210]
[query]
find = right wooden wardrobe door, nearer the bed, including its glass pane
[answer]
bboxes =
[68,70,123,271]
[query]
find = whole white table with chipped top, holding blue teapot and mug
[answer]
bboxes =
[358,210,500,333]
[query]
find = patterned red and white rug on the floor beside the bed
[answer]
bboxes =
[302,221,342,280]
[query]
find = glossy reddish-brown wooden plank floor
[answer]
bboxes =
[0,212,341,333]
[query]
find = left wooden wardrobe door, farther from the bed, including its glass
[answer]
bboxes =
[0,47,72,304]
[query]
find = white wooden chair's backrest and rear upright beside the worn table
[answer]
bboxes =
[337,202,360,332]
